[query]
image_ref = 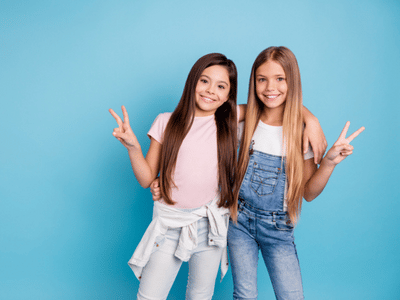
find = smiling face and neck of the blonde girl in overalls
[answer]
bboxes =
[256,60,288,113]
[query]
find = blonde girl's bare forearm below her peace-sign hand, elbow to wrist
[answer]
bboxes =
[304,159,335,202]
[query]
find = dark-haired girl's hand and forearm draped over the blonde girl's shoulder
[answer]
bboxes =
[303,106,328,164]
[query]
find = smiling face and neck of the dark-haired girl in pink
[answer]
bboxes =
[195,65,230,117]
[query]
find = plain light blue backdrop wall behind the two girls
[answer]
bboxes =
[0,0,400,300]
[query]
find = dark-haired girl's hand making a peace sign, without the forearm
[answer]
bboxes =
[108,105,140,151]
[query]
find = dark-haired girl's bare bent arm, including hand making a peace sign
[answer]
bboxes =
[109,106,161,188]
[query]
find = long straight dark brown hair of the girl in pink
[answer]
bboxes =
[160,53,237,207]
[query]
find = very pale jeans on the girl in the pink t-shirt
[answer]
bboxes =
[137,218,223,300]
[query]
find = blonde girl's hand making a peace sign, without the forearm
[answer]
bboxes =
[325,121,365,166]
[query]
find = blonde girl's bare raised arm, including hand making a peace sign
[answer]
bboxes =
[303,122,365,202]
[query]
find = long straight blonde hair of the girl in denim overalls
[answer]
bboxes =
[231,47,304,223]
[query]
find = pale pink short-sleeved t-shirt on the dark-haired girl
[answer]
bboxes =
[147,113,218,208]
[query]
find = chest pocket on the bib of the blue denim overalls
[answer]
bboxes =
[250,162,280,196]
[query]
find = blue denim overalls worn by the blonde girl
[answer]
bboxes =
[228,149,303,300]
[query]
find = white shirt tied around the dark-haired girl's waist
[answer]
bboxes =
[128,195,229,280]
